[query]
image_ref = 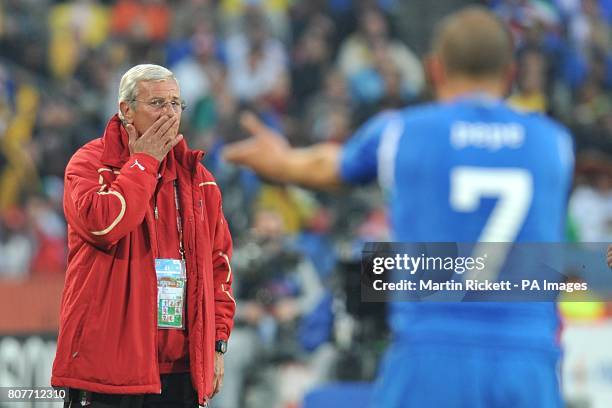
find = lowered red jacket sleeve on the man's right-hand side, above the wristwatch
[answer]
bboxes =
[212,194,236,341]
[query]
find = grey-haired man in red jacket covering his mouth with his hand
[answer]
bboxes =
[51,65,236,408]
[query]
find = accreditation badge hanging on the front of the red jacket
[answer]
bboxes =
[155,259,187,329]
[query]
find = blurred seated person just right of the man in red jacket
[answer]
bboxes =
[215,207,331,408]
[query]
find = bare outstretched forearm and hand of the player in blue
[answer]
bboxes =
[223,113,342,189]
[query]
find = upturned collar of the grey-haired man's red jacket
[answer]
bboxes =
[101,114,204,181]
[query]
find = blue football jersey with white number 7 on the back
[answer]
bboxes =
[340,96,573,348]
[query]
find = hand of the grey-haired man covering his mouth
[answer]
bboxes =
[125,115,183,161]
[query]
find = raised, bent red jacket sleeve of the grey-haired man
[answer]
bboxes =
[64,153,159,250]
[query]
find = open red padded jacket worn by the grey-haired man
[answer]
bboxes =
[51,116,236,404]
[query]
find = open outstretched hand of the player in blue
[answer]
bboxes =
[223,113,290,179]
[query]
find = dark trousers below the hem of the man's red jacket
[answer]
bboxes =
[64,373,198,408]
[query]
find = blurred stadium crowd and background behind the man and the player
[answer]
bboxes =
[0,0,612,408]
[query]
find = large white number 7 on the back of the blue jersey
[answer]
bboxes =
[450,166,533,242]
